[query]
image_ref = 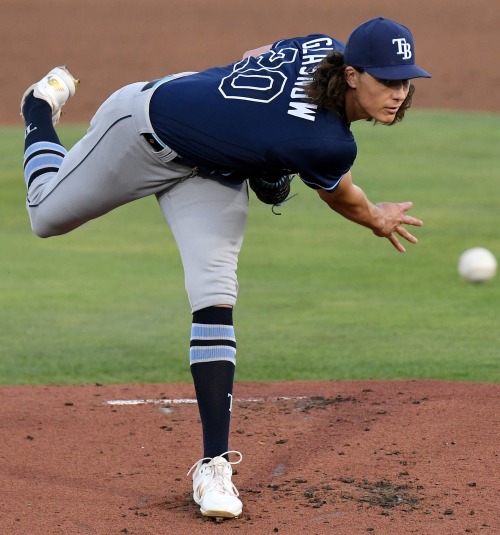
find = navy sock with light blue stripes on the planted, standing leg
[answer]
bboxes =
[190,307,236,458]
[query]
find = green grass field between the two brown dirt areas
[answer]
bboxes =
[0,111,500,384]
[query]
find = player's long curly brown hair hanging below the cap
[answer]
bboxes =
[305,52,415,126]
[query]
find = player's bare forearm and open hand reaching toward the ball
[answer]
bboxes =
[318,172,423,253]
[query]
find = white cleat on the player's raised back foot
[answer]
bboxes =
[21,66,80,125]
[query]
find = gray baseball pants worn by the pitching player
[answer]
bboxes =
[27,82,248,312]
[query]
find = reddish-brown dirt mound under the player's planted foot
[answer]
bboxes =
[0,381,500,535]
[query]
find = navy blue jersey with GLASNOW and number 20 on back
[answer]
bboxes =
[150,34,357,190]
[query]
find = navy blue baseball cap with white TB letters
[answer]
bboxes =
[344,17,431,80]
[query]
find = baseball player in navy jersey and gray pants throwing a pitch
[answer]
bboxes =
[21,17,430,518]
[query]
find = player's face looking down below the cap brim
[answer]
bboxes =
[346,69,410,124]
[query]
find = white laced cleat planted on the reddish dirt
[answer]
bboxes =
[188,451,243,518]
